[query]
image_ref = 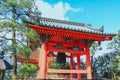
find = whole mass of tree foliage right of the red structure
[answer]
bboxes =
[92,31,120,80]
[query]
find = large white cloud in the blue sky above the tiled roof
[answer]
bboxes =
[36,0,83,20]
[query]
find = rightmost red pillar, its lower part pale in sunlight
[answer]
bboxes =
[86,47,92,79]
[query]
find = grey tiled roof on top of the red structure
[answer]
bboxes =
[40,17,103,34]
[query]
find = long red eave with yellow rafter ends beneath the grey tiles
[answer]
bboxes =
[29,25,115,41]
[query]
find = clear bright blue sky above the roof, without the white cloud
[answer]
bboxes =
[37,0,120,33]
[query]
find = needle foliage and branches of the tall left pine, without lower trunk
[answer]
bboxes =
[0,0,40,52]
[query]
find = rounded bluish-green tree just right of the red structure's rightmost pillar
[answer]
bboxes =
[93,52,119,79]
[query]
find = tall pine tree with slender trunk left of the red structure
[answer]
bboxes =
[0,0,40,80]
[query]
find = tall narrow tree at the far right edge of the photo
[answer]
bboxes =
[108,31,120,80]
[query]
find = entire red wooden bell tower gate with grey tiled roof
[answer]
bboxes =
[19,17,115,79]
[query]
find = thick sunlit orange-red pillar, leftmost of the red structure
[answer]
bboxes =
[37,43,47,79]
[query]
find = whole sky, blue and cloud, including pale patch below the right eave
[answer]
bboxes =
[36,0,120,56]
